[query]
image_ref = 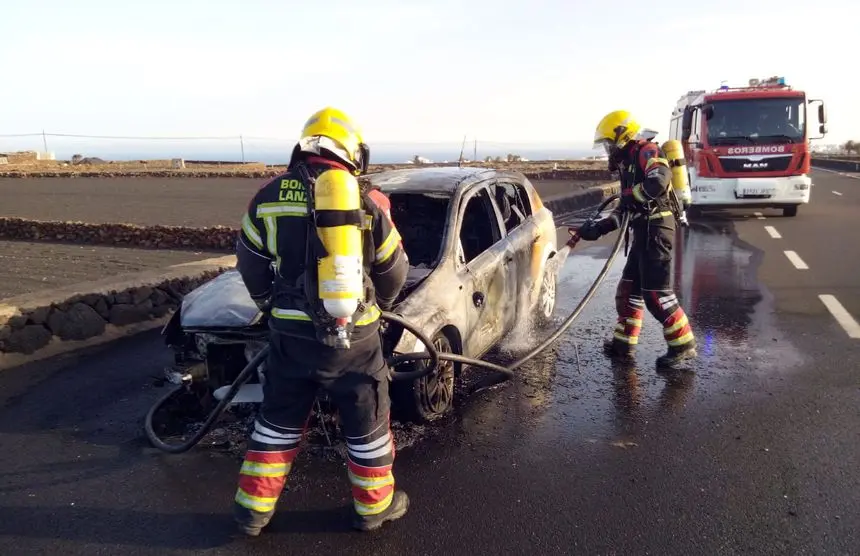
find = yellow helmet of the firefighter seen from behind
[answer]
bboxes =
[294,107,370,176]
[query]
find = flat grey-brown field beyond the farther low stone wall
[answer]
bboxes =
[0,178,592,227]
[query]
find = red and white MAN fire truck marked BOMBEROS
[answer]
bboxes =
[669,77,827,216]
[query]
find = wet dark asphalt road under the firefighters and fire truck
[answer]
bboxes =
[0,172,860,555]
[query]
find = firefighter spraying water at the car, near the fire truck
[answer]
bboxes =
[572,110,697,368]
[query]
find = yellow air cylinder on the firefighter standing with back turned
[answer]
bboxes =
[314,170,364,320]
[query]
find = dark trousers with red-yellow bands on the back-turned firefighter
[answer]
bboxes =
[234,333,394,527]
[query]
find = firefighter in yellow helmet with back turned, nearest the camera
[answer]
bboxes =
[234,108,409,536]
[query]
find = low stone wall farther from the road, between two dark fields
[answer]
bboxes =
[0,217,238,252]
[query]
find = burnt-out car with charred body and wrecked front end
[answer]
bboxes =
[163,167,558,421]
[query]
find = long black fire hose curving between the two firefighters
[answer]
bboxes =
[144,195,630,454]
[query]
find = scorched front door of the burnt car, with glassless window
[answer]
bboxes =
[458,185,516,356]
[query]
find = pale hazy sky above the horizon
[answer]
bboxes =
[0,0,860,159]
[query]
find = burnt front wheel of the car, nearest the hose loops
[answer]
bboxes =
[391,331,456,423]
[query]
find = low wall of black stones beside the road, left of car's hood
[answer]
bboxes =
[0,269,225,355]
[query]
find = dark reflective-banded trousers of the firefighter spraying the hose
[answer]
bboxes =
[613,216,695,352]
